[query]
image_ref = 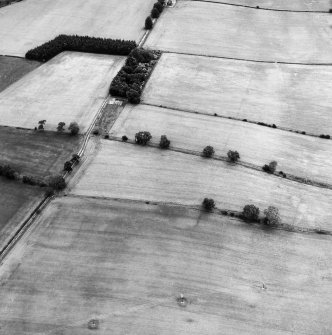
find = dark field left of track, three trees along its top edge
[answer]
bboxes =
[0,127,83,178]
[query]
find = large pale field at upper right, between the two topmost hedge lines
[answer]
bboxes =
[144,1,332,64]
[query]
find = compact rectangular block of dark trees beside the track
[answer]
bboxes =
[110,48,160,104]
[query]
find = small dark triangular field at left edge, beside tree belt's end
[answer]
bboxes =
[0,56,40,92]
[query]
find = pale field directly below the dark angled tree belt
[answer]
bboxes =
[0,51,125,132]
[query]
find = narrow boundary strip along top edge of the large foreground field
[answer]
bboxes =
[66,194,332,236]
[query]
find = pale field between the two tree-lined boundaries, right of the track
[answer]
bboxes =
[71,140,332,229]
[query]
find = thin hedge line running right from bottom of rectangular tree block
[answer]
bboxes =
[141,102,332,141]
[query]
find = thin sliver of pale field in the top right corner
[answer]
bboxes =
[200,0,332,12]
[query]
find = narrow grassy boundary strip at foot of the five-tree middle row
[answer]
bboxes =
[108,135,332,190]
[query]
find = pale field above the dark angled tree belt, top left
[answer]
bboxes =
[0,0,155,56]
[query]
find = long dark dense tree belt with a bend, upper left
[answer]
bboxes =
[25,35,137,62]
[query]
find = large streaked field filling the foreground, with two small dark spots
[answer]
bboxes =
[0,197,332,335]
